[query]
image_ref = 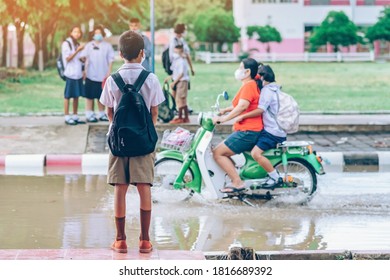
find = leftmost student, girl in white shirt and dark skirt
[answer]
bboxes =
[61,26,84,125]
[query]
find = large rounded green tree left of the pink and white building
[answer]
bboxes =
[194,7,240,51]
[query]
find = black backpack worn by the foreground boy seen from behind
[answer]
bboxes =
[108,70,158,157]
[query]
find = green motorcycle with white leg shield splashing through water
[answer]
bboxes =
[152,92,325,206]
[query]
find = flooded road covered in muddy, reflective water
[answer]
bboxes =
[0,172,390,252]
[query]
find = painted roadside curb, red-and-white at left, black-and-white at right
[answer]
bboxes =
[0,152,390,176]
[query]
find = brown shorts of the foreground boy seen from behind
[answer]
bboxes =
[107,152,155,186]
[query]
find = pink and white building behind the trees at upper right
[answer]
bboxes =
[233,0,390,54]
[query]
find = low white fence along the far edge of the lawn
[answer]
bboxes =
[196,51,375,64]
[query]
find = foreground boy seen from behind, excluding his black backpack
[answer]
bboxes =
[100,31,165,253]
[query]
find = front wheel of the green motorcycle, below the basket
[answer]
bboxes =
[152,158,194,203]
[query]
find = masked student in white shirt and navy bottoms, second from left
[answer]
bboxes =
[81,25,115,122]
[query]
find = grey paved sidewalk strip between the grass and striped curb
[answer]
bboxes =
[0,114,390,155]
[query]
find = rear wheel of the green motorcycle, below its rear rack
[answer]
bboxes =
[275,158,317,198]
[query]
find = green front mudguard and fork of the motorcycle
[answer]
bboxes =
[156,150,202,193]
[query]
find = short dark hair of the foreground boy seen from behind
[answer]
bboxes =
[119,31,145,61]
